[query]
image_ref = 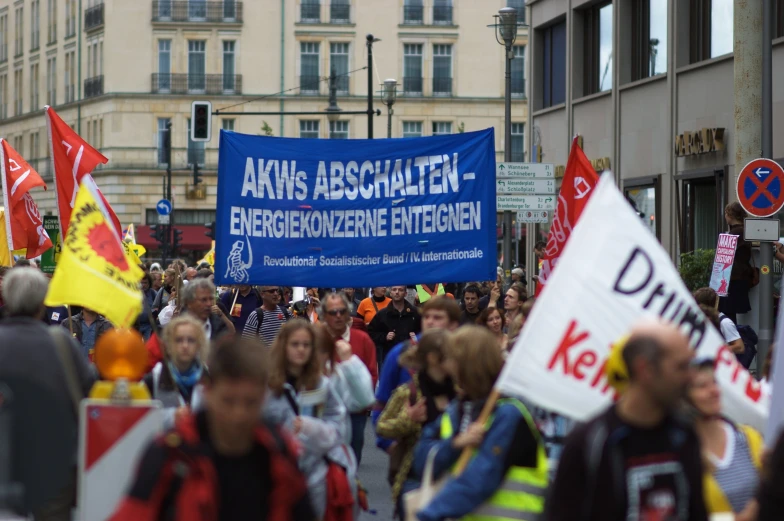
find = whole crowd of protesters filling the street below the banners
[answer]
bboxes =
[0,244,784,521]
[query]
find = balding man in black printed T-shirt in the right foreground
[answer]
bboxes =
[545,320,707,521]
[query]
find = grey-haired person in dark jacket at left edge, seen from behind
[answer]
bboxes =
[0,267,95,521]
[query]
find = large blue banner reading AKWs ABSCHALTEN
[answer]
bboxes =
[215,129,496,287]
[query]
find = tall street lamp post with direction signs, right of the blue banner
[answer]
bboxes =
[494,7,517,284]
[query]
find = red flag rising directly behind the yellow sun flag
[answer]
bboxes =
[46,105,122,237]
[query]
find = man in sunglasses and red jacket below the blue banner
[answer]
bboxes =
[319,293,378,464]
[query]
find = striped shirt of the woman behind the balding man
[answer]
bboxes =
[710,422,759,512]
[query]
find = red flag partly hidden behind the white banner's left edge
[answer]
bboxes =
[536,137,599,296]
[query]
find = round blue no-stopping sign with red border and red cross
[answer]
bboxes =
[736,159,784,217]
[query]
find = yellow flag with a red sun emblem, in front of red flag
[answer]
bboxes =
[45,176,144,327]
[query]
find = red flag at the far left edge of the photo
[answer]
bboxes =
[0,139,52,259]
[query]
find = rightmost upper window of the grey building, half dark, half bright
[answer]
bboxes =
[689,0,734,63]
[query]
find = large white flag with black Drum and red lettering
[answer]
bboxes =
[496,174,770,429]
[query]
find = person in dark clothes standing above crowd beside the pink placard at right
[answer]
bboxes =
[719,201,759,324]
